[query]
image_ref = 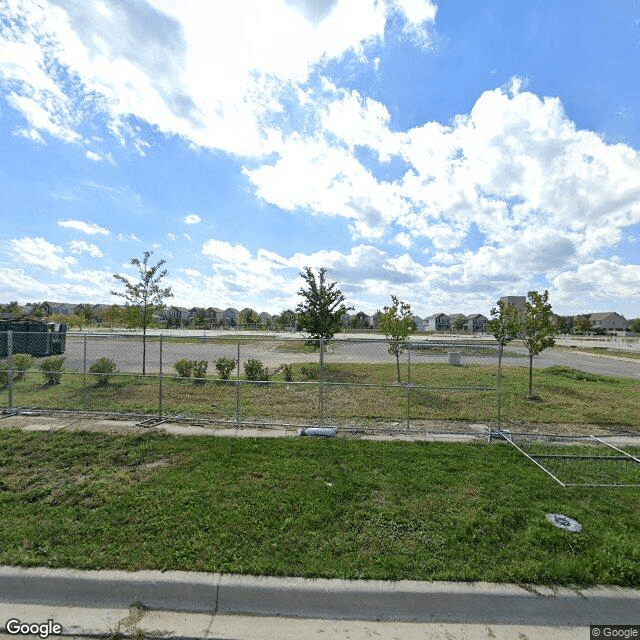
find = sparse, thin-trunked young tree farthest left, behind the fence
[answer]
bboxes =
[110,251,173,375]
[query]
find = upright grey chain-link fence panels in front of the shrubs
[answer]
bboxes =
[0,331,500,430]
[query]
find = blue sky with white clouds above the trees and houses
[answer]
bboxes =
[0,0,640,319]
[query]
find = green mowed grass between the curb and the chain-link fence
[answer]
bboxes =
[0,430,640,587]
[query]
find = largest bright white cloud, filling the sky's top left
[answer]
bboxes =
[0,0,435,159]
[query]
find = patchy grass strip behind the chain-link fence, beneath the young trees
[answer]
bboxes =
[0,362,640,431]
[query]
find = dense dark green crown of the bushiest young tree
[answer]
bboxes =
[296,267,352,346]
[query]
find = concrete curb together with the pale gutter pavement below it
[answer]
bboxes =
[0,567,640,639]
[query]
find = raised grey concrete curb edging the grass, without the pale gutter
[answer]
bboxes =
[0,567,640,626]
